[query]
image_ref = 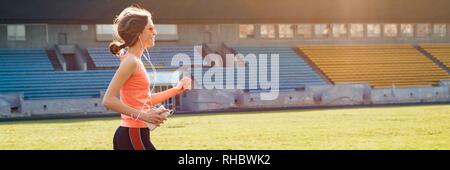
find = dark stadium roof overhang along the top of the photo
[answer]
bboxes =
[0,0,450,24]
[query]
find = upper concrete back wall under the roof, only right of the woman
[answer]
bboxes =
[168,23,450,46]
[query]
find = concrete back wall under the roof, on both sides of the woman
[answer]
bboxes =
[0,23,450,48]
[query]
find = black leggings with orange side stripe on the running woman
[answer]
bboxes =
[113,126,156,150]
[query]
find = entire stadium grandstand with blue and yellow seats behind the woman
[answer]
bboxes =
[0,0,450,117]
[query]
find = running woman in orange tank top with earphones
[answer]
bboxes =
[102,6,191,150]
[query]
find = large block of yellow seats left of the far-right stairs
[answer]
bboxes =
[298,44,450,88]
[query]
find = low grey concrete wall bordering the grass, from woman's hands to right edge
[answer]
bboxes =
[176,82,450,111]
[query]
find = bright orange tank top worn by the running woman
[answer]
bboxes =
[120,55,151,128]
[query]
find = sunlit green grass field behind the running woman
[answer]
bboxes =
[0,105,450,150]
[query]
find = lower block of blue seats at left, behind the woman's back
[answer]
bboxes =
[0,70,115,100]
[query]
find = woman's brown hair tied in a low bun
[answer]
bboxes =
[109,5,152,56]
